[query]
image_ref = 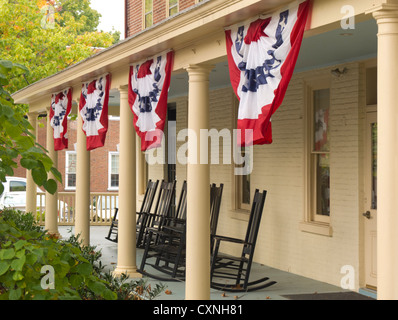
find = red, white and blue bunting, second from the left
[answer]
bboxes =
[79,74,111,150]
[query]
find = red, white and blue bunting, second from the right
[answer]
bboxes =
[128,51,174,151]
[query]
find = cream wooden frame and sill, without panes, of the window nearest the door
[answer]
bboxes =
[300,78,333,236]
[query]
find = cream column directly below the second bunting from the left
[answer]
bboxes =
[75,102,90,245]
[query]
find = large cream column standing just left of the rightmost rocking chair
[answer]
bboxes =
[185,65,213,300]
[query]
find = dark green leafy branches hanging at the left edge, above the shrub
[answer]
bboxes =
[0,60,62,194]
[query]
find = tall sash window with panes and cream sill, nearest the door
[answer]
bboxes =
[301,81,331,236]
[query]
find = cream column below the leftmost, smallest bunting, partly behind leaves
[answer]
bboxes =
[45,108,59,235]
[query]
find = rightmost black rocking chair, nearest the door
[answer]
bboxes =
[210,190,276,292]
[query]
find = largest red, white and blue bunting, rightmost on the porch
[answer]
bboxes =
[225,0,310,146]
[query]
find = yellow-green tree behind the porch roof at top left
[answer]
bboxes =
[0,0,114,92]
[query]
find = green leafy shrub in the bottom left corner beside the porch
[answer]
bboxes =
[0,210,163,300]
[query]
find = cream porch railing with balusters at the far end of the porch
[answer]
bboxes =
[36,192,119,226]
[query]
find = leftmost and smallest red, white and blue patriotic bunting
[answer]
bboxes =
[50,88,72,151]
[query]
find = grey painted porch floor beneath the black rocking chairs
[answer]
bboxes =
[58,226,375,300]
